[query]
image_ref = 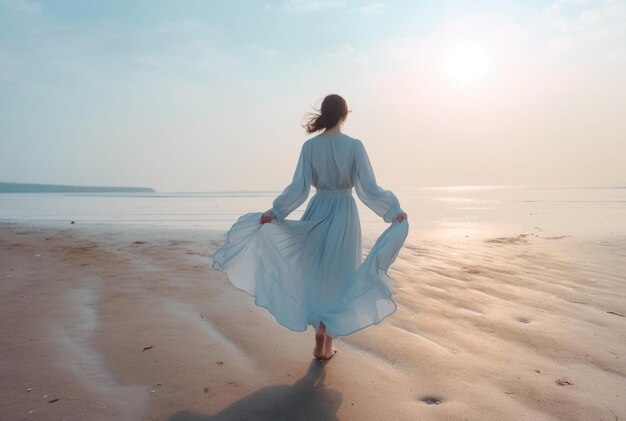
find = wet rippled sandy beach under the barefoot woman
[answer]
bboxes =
[0,223,626,421]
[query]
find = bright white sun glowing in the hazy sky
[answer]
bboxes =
[443,41,491,82]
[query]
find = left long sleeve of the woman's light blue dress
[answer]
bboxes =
[270,144,313,221]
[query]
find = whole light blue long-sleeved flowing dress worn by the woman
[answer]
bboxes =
[213,133,408,337]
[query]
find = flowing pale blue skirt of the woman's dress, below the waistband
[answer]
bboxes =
[213,190,408,337]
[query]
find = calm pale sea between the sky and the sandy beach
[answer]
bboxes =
[0,186,626,238]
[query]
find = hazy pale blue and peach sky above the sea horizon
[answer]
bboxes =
[0,0,626,192]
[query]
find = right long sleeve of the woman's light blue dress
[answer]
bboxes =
[354,141,403,222]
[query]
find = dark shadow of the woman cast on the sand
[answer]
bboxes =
[167,360,341,421]
